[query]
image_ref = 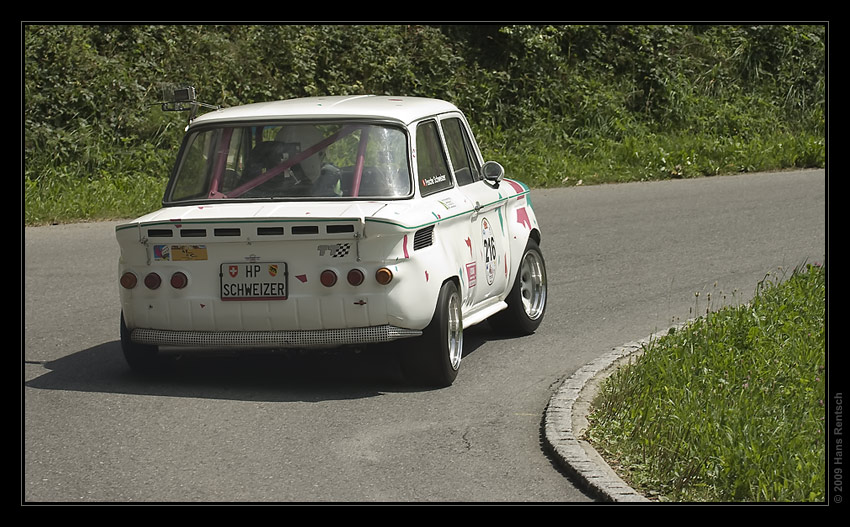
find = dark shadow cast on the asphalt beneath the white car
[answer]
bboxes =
[25,326,500,402]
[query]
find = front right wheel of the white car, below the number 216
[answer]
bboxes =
[490,239,547,335]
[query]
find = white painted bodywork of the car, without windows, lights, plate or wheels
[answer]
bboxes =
[116,97,540,356]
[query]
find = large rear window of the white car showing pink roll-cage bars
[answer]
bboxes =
[166,122,412,202]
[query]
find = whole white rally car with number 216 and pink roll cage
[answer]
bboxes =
[116,96,546,386]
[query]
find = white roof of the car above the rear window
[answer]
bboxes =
[192,95,459,126]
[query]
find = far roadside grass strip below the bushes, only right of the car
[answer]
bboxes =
[477,120,825,188]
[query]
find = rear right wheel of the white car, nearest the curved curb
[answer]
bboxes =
[401,280,463,388]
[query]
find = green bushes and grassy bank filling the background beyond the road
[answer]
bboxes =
[23,25,826,223]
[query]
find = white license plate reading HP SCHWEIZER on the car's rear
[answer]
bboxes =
[221,262,287,300]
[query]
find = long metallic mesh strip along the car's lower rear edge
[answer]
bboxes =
[130,325,422,348]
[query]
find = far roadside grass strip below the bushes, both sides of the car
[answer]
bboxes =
[23,126,825,225]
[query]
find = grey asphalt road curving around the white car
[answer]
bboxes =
[21,170,827,503]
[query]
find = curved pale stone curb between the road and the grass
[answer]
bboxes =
[543,324,685,503]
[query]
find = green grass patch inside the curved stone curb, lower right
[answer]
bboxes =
[588,265,826,502]
